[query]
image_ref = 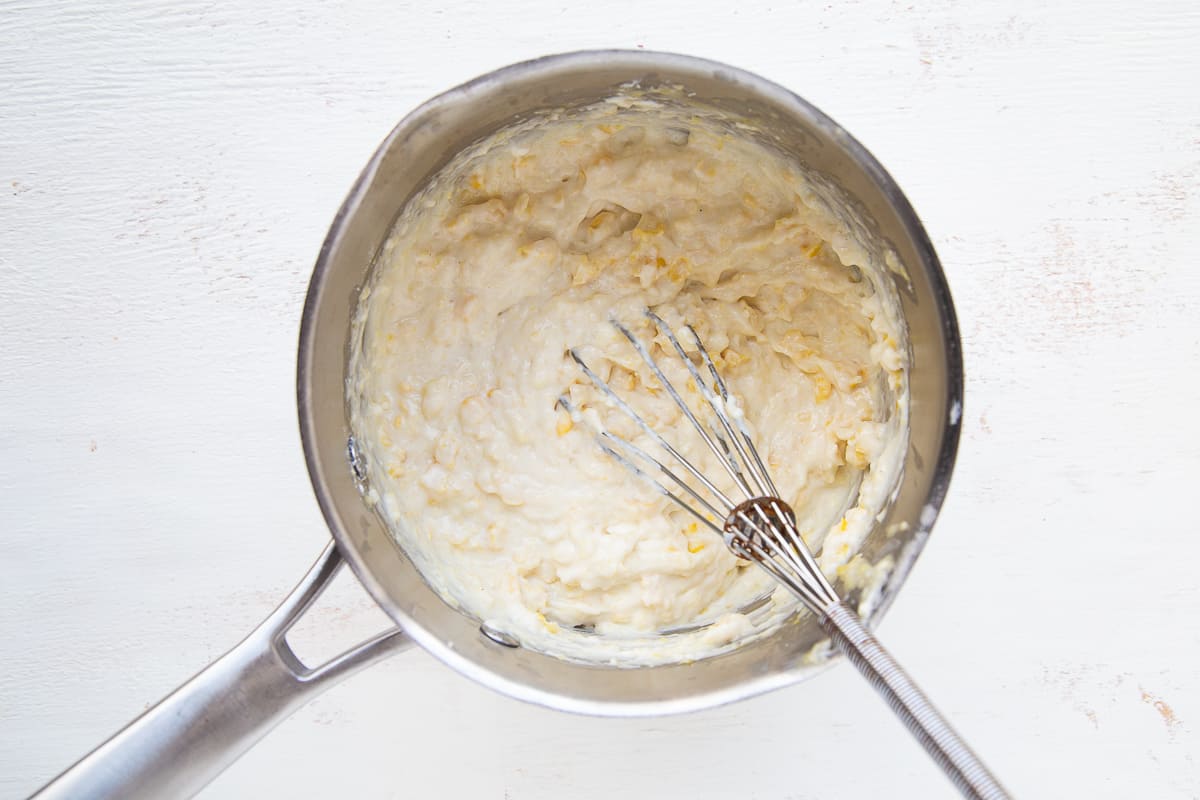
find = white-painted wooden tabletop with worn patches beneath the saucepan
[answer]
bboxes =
[0,0,1200,800]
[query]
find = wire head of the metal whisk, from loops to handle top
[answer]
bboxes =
[558,309,838,614]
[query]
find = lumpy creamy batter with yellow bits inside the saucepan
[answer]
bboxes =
[348,95,907,664]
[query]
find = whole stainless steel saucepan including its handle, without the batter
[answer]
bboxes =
[38,50,962,798]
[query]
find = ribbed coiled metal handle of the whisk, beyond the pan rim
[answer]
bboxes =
[822,602,1009,800]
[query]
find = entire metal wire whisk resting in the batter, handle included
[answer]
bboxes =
[559,309,1008,800]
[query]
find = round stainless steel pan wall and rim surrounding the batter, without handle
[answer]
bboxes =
[298,52,962,715]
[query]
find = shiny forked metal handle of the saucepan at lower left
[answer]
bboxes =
[34,542,412,800]
